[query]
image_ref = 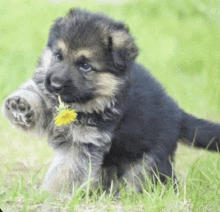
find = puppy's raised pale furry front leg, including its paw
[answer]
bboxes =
[2,79,49,135]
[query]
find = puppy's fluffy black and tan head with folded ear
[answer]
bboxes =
[41,10,138,109]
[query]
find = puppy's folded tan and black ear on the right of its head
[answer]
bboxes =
[108,29,138,69]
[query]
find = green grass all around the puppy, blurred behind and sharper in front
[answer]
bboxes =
[0,0,220,212]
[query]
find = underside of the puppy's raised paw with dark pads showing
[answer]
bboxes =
[5,96,35,129]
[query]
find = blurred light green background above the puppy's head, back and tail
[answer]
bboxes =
[0,0,220,121]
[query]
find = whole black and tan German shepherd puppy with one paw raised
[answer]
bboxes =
[3,9,220,193]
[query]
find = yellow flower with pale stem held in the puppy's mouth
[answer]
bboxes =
[55,96,77,126]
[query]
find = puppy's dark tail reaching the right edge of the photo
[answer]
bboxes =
[180,113,220,151]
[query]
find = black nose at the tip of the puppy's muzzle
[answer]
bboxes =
[45,76,64,93]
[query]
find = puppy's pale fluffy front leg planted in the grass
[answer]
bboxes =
[43,143,103,194]
